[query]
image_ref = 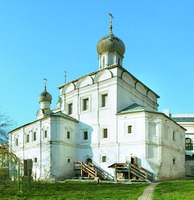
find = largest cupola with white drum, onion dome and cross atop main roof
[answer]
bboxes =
[96,14,125,69]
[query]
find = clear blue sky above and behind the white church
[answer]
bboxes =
[0,0,194,126]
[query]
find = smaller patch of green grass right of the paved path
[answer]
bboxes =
[153,180,194,200]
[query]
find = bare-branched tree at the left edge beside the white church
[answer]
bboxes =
[0,114,13,145]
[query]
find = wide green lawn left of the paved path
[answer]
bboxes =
[0,182,148,200]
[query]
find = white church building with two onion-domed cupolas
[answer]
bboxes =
[9,18,186,180]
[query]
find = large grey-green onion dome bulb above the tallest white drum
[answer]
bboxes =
[97,32,125,56]
